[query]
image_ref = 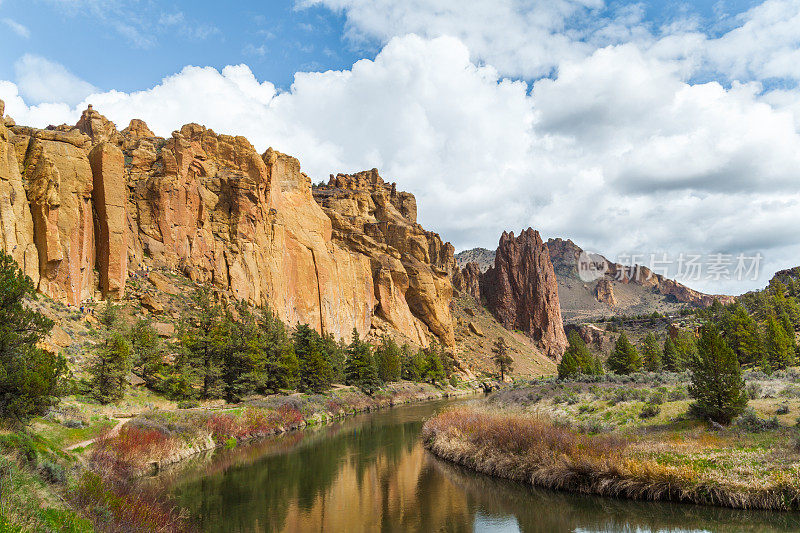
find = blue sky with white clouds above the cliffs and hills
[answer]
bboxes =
[0,0,800,294]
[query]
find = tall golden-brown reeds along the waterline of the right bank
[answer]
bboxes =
[422,407,800,510]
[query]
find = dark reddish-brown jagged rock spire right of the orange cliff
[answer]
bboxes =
[478,228,567,360]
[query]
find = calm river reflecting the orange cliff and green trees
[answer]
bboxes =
[169,400,800,533]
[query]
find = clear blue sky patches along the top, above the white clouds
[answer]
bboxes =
[0,0,757,91]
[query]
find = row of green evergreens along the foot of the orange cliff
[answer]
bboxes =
[88,289,454,403]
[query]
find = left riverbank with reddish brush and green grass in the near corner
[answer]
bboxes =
[0,382,482,533]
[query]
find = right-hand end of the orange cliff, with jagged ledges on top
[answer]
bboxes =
[314,169,456,346]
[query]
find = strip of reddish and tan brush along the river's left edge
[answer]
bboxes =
[94,381,482,478]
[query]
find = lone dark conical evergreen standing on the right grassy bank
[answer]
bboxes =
[689,325,747,424]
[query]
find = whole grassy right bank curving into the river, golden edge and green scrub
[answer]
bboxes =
[423,373,800,510]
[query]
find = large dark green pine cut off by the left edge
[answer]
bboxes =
[0,251,67,425]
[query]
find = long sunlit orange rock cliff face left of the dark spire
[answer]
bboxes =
[0,102,455,345]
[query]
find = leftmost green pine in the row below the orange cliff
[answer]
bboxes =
[89,331,131,404]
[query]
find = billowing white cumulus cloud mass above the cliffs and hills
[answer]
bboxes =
[0,22,800,292]
